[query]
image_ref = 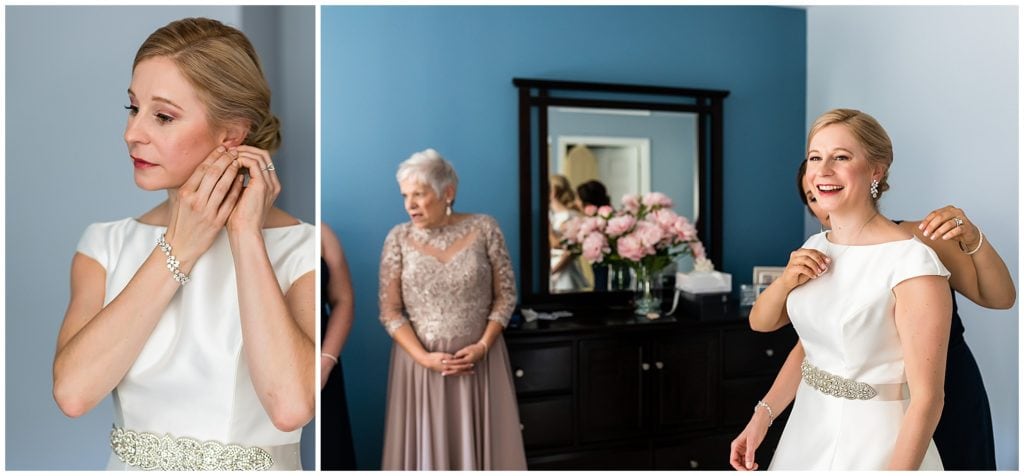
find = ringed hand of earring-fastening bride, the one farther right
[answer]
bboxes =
[227,145,281,233]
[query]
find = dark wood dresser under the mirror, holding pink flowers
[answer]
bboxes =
[505,306,797,470]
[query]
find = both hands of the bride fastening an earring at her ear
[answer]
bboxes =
[166,145,281,267]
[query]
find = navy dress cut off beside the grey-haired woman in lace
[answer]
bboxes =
[319,258,355,470]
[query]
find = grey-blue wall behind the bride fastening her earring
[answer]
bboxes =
[4,6,315,470]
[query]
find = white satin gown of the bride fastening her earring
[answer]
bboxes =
[78,218,318,470]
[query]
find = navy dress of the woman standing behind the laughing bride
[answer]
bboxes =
[933,288,995,471]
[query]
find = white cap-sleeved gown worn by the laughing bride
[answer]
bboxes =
[769,232,949,470]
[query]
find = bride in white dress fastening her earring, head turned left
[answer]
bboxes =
[53,18,317,470]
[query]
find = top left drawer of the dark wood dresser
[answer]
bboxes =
[509,342,572,393]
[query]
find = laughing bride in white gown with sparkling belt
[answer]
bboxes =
[730,110,951,470]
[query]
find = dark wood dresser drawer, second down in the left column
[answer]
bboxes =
[519,395,572,449]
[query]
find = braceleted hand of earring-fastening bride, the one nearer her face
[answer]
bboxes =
[166,146,242,266]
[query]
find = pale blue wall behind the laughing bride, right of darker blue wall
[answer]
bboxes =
[806,6,1020,470]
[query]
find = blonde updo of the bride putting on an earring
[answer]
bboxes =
[132,18,281,154]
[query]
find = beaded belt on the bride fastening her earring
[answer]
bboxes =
[111,427,273,471]
